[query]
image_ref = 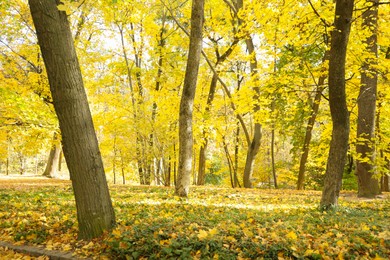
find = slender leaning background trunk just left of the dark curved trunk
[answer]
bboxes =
[297,76,326,190]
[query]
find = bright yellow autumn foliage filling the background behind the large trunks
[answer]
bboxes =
[0,0,390,197]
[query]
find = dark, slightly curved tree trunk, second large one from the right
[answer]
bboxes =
[320,0,354,210]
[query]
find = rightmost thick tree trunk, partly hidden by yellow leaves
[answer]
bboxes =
[356,0,380,198]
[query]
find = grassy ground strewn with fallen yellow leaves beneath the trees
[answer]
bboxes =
[0,178,390,259]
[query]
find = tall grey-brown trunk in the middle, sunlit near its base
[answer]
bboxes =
[175,0,204,197]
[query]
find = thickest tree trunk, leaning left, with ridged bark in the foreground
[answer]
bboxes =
[29,0,115,239]
